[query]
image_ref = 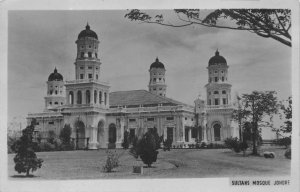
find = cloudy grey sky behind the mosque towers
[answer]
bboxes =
[8,10,292,127]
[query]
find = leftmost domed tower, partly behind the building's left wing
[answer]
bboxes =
[45,68,65,110]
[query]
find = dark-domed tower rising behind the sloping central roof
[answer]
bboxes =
[148,58,167,97]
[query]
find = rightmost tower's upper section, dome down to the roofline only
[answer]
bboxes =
[205,50,231,107]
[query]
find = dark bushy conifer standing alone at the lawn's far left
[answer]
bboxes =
[13,119,43,177]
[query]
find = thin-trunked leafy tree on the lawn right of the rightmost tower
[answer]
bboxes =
[232,91,278,155]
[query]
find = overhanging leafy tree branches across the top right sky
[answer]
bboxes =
[125,9,292,47]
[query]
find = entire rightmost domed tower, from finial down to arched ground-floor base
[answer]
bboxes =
[204,50,234,143]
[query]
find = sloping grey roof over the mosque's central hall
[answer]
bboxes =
[109,90,186,107]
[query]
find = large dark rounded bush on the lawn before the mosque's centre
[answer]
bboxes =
[130,128,162,167]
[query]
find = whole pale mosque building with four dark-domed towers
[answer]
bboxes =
[27,25,238,149]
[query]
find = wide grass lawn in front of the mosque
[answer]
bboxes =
[8,147,291,180]
